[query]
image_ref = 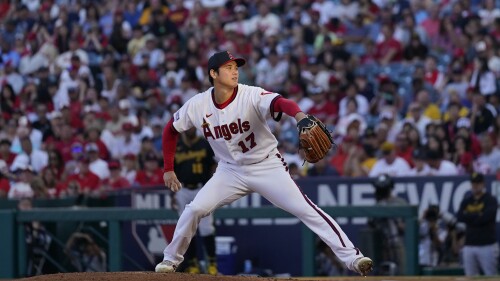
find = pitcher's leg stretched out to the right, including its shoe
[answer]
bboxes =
[248,154,372,275]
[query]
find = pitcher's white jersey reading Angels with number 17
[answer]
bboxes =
[173,84,279,165]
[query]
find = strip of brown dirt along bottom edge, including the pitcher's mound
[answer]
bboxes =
[16,272,482,281]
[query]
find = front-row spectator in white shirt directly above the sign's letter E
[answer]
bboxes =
[369,142,411,177]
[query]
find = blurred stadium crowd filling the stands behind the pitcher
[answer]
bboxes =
[0,0,500,198]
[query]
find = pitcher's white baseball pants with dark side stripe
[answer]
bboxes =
[163,150,363,270]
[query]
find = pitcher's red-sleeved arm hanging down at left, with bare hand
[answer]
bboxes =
[162,119,181,192]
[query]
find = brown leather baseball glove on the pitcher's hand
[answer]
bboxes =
[297,114,335,163]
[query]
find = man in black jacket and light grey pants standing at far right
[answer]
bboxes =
[457,173,498,276]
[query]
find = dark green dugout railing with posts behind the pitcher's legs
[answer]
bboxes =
[0,206,418,278]
